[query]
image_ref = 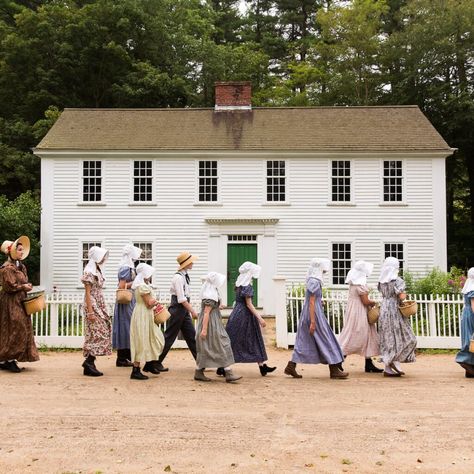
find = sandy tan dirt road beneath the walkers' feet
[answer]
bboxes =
[0,334,474,473]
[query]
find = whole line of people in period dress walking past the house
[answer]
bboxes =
[0,236,474,382]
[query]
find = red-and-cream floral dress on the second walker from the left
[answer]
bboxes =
[81,272,112,357]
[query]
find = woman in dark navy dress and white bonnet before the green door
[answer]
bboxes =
[224,262,276,376]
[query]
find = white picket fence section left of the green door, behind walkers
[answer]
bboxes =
[32,293,199,348]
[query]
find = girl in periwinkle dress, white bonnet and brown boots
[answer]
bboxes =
[285,258,349,379]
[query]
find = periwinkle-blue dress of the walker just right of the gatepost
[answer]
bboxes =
[291,278,344,365]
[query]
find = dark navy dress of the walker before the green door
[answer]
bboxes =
[226,285,267,362]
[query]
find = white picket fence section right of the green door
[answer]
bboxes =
[277,284,464,349]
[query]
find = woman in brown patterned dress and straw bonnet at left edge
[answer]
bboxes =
[0,236,39,373]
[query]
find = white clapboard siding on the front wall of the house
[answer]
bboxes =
[41,152,446,308]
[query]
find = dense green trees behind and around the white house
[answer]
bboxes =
[0,0,474,279]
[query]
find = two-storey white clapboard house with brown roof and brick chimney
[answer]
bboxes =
[34,82,453,314]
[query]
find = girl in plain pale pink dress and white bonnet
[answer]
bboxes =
[339,260,383,373]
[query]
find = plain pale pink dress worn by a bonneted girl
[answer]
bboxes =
[339,285,380,357]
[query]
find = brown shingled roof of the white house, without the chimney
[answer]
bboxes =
[36,106,452,152]
